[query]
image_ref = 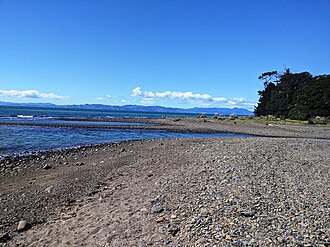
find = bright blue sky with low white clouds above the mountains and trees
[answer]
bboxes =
[0,0,330,110]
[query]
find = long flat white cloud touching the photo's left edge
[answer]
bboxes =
[0,90,69,99]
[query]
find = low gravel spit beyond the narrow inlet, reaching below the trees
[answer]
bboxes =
[0,117,330,139]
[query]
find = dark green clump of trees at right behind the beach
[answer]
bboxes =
[254,69,330,120]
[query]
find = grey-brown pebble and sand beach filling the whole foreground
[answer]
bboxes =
[0,118,330,246]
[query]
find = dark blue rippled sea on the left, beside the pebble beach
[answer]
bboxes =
[0,106,246,159]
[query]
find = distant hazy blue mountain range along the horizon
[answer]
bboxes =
[0,101,253,116]
